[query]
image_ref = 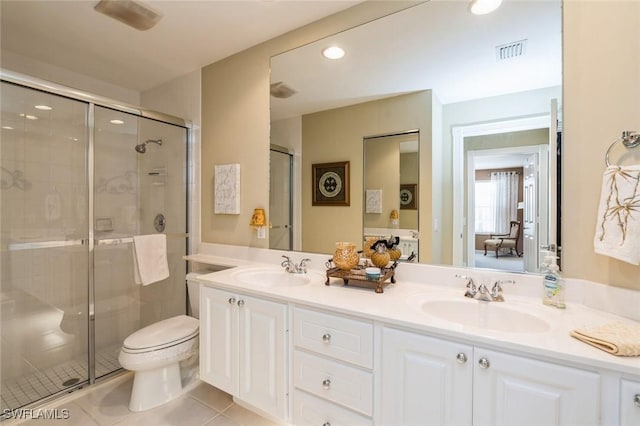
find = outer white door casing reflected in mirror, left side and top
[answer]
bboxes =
[451,114,550,266]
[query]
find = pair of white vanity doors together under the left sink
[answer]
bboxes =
[200,286,288,419]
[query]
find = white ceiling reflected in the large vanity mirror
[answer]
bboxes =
[271,0,562,119]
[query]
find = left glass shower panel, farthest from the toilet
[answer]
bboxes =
[0,82,89,413]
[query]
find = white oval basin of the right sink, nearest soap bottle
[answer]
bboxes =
[420,300,551,333]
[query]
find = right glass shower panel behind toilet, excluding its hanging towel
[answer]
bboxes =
[93,106,187,378]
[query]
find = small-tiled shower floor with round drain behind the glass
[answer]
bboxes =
[0,345,120,413]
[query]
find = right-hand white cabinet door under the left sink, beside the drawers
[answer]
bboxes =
[237,296,287,418]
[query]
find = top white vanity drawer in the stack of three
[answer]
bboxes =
[293,307,373,368]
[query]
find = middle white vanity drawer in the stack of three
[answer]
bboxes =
[293,351,373,416]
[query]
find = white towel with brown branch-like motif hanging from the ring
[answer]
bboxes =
[593,165,640,265]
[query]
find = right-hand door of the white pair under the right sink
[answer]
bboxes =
[473,348,600,426]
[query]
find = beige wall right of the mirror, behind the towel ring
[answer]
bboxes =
[562,0,640,289]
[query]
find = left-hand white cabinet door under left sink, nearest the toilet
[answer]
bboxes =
[200,287,238,395]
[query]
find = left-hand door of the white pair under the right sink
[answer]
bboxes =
[382,328,473,426]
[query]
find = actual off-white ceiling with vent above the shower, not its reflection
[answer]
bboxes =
[0,0,362,91]
